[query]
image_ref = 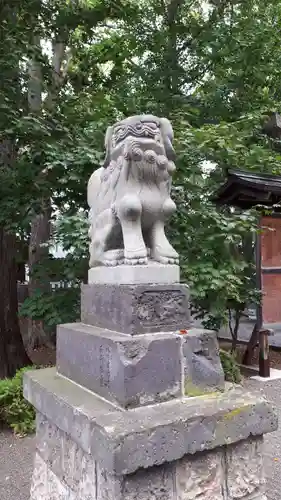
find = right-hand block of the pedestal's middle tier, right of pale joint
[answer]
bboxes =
[182,328,224,396]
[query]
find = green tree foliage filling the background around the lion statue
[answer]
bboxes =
[0,0,281,348]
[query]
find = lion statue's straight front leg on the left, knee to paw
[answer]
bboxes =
[116,194,147,265]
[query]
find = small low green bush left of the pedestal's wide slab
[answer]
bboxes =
[0,367,35,435]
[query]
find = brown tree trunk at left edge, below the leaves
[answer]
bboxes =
[0,226,32,379]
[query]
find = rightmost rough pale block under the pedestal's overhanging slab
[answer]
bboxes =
[226,437,265,500]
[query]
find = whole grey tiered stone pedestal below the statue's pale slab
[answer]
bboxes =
[24,271,277,500]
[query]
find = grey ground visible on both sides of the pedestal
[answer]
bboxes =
[0,379,281,500]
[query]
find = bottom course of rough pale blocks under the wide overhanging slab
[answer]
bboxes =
[31,416,266,500]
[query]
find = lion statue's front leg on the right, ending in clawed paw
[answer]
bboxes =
[150,198,179,264]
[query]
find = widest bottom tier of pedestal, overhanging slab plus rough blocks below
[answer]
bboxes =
[24,369,277,500]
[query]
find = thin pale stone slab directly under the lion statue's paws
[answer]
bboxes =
[88,261,180,285]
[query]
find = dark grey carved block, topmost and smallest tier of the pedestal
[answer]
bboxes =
[81,284,190,335]
